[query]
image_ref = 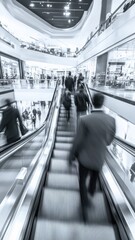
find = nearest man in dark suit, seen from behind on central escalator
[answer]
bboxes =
[69,93,115,206]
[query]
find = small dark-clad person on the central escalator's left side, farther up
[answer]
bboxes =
[63,89,71,122]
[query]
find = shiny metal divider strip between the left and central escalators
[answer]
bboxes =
[0,85,59,239]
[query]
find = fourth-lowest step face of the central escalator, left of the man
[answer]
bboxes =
[49,159,77,174]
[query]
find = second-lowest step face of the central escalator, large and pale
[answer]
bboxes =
[39,188,82,222]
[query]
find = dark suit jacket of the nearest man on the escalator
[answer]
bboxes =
[70,110,116,171]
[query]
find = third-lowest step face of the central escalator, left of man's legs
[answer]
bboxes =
[46,173,79,191]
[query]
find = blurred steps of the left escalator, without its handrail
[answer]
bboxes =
[0,132,44,203]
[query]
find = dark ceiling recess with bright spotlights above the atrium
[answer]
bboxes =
[17,0,93,29]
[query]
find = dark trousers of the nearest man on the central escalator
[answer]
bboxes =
[79,163,99,206]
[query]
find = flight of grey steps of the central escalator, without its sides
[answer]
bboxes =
[30,95,120,240]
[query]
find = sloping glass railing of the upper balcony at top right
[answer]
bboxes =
[76,0,135,56]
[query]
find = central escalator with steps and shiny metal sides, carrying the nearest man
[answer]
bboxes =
[0,87,134,240]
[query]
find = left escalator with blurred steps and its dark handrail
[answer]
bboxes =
[0,82,58,204]
